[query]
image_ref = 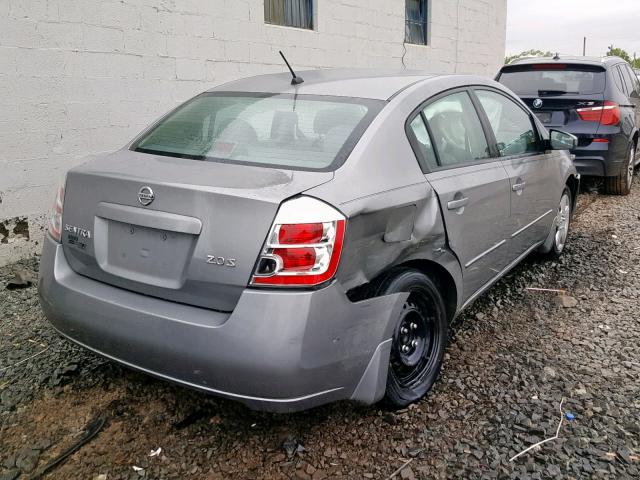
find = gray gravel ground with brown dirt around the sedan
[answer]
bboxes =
[0,182,640,480]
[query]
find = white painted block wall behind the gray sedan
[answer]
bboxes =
[0,0,507,265]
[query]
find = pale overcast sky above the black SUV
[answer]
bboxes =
[507,0,640,58]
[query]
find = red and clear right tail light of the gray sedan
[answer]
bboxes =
[251,197,346,286]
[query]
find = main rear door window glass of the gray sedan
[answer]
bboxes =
[422,92,491,167]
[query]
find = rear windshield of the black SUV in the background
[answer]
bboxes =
[498,64,605,97]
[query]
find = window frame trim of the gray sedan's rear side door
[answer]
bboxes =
[404,85,504,174]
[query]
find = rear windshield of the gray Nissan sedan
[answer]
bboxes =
[132,92,384,171]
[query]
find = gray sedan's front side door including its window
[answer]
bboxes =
[474,88,562,257]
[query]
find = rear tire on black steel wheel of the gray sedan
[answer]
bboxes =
[377,268,448,409]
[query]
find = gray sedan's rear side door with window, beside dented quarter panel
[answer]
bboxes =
[409,90,510,299]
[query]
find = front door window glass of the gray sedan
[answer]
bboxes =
[476,90,540,157]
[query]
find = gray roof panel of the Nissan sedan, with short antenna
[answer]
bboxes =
[208,67,437,100]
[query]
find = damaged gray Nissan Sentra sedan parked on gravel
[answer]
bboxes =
[39,70,579,411]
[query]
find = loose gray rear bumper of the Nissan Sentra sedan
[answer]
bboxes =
[38,236,406,412]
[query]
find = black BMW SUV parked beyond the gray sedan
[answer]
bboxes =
[496,56,640,195]
